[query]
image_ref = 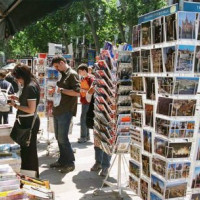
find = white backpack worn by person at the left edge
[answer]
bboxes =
[0,83,11,112]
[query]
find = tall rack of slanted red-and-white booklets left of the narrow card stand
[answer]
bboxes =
[94,46,116,155]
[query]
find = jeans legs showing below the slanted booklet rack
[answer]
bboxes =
[94,147,111,169]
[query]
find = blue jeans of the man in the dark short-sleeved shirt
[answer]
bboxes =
[53,112,75,165]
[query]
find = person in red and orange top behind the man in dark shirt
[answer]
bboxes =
[77,63,94,143]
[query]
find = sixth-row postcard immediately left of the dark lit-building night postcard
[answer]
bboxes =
[154,137,168,157]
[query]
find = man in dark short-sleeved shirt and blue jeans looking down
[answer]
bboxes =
[50,55,80,173]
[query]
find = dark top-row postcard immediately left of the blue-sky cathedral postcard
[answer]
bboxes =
[165,13,177,42]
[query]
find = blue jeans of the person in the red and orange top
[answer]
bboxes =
[81,104,90,138]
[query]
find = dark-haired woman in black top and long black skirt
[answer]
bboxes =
[9,63,40,177]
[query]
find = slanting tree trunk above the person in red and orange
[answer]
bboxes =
[83,1,100,54]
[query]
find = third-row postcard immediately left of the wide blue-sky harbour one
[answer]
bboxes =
[157,77,174,95]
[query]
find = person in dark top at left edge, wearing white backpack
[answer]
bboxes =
[0,69,14,124]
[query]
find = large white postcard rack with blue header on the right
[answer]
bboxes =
[129,2,200,200]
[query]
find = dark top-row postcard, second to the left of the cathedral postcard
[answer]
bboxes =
[152,17,164,44]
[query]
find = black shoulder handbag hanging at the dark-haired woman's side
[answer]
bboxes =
[10,109,37,147]
